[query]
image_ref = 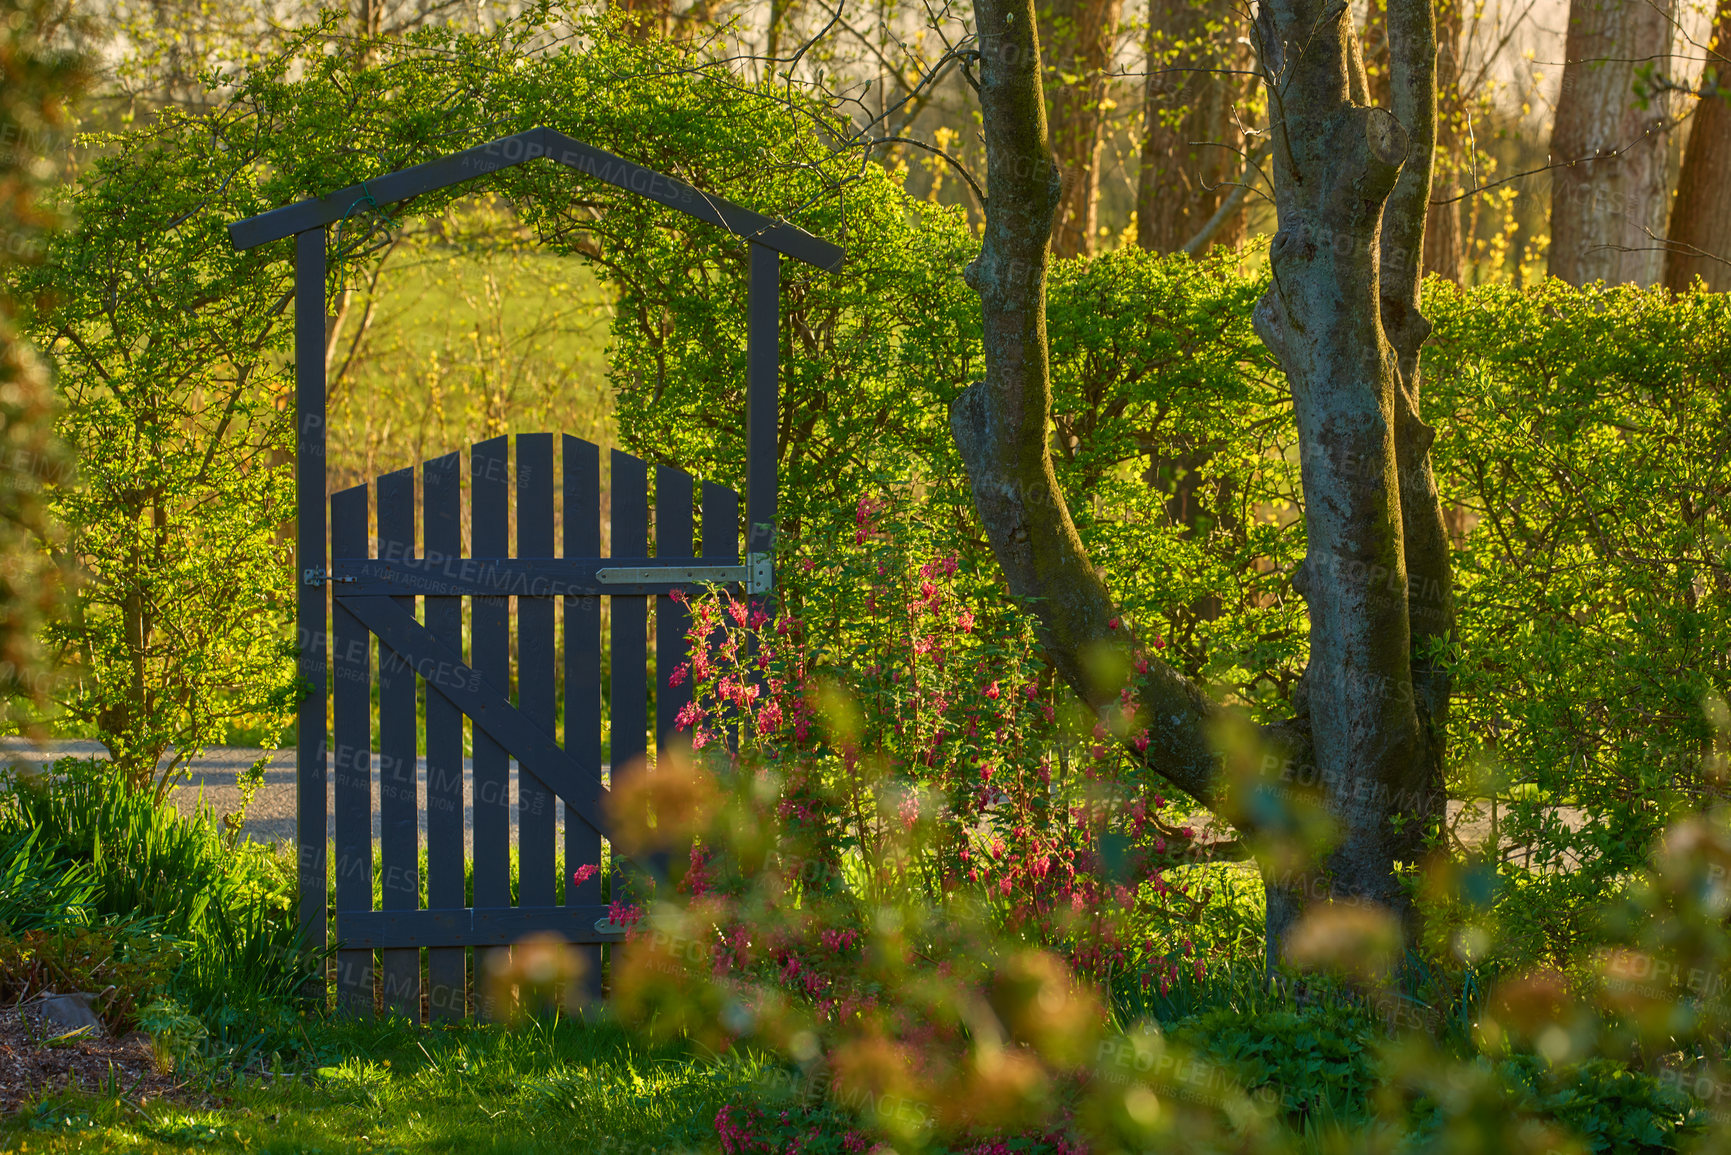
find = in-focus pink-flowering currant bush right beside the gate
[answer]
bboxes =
[654,497,1225,984]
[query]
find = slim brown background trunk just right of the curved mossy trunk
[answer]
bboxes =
[1039,0,1123,256]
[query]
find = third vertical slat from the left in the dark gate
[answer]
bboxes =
[421,454,467,1020]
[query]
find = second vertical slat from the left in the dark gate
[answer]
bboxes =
[379,469,421,1022]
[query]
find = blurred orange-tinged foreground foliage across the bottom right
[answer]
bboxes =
[609,637,1731,1155]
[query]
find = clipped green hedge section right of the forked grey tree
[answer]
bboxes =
[1425,281,1731,958]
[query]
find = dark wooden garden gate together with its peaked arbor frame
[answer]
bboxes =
[228,128,843,1018]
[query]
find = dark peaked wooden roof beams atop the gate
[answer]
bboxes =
[228,126,845,270]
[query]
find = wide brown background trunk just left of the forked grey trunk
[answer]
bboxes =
[1136,0,1253,253]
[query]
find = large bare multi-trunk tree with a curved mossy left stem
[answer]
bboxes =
[950,0,1454,952]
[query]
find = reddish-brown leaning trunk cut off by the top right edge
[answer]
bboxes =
[1665,0,1731,293]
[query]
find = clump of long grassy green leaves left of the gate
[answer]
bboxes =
[0,758,320,1061]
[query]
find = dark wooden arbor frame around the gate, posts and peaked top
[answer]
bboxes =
[228,126,845,997]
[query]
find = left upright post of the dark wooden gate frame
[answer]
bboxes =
[294,225,327,955]
